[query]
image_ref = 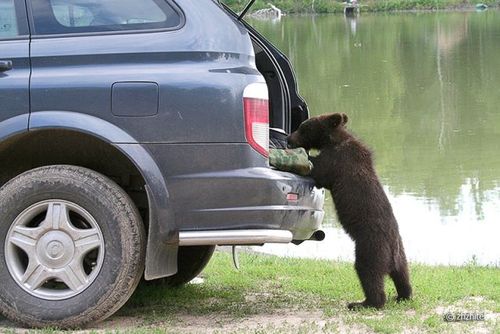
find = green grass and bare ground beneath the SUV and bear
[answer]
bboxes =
[1,252,500,334]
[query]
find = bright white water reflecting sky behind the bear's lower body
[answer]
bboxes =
[254,184,500,266]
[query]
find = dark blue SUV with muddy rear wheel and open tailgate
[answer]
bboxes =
[0,0,324,328]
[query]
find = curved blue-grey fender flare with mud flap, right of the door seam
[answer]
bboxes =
[28,111,179,280]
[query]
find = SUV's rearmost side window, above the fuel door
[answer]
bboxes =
[30,0,181,35]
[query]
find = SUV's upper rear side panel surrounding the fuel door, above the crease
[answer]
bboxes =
[31,1,262,143]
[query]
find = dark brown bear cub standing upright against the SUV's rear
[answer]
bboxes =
[288,113,412,309]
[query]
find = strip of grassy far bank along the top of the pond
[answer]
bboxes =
[223,0,500,14]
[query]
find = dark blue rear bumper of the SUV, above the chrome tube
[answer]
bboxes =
[168,167,324,240]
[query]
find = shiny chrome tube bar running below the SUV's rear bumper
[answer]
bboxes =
[179,230,293,246]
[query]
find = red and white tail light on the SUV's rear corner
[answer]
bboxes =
[243,83,269,157]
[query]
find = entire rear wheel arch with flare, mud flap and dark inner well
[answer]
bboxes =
[0,111,178,279]
